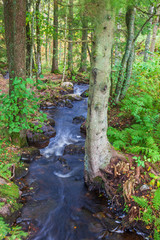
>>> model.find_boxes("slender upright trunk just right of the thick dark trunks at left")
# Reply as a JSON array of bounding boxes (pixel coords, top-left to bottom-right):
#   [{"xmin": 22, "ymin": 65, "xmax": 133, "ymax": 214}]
[{"xmin": 36, "ymin": 0, "xmax": 42, "ymax": 76}]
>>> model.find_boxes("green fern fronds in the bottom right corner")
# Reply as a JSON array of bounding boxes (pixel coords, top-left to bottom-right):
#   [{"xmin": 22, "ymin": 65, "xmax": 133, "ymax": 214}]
[{"xmin": 133, "ymin": 188, "xmax": 160, "ymax": 240}]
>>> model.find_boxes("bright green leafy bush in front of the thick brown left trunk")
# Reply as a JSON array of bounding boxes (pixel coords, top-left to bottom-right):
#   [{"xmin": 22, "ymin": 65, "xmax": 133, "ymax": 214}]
[{"xmin": 0, "ymin": 77, "xmax": 46, "ymax": 135}]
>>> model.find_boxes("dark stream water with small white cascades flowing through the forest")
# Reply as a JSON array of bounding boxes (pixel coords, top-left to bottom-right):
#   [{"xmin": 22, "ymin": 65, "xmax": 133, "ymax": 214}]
[{"xmin": 22, "ymin": 86, "xmax": 143, "ymax": 240}]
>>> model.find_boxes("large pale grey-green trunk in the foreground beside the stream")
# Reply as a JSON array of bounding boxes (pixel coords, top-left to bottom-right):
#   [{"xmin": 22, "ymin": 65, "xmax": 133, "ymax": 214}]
[{"xmin": 85, "ymin": 0, "xmax": 114, "ymax": 184}]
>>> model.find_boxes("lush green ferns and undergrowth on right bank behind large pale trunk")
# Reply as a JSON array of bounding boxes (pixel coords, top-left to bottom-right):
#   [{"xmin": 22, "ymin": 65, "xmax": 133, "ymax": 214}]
[{"xmin": 108, "ymin": 60, "xmax": 160, "ymax": 162}]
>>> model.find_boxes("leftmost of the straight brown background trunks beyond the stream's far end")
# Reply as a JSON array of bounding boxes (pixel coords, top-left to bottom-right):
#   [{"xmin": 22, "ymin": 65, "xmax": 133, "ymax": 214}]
[{"xmin": 51, "ymin": 0, "xmax": 58, "ymax": 73}]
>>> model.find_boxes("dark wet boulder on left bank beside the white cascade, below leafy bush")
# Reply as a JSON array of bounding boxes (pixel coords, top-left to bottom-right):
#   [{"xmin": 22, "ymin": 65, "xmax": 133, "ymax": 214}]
[{"xmin": 27, "ymin": 125, "xmax": 56, "ymax": 148}]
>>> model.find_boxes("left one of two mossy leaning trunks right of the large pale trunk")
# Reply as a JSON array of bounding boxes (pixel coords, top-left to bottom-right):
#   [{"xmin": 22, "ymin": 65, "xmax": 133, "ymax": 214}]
[{"xmin": 115, "ymin": 7, "xmax": 135, "ymax": 103}]
